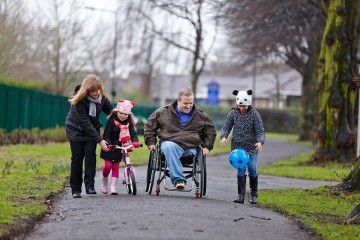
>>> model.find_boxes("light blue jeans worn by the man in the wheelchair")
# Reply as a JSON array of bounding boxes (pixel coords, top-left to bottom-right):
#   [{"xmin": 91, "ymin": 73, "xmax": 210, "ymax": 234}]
[{"xmin": 161, "ymin": 141, "xmax": 197, "ymax": 185}]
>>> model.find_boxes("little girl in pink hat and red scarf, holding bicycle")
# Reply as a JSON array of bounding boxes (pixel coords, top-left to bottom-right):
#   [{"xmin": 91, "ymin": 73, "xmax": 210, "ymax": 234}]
[{"xmin": 100, "ymin": 100, "xmax": 140, "ymax": 195}]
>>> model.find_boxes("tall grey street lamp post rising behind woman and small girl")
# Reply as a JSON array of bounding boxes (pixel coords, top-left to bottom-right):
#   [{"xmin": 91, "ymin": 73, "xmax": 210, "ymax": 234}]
[{"xmin": 85, "ymin": 6, "xmax": 120, "ymax": 101}]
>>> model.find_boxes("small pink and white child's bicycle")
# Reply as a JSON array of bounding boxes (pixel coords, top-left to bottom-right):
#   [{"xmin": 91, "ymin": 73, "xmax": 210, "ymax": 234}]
[{"xmin": 108, "ymin": 144, "xmax": 142, "ymax": 195}]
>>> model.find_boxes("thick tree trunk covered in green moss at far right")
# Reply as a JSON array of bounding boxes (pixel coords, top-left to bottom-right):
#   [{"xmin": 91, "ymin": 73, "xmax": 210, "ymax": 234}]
[{"xmin": 312, "ymin": 0, "xmax": 359, "ymax": 162}]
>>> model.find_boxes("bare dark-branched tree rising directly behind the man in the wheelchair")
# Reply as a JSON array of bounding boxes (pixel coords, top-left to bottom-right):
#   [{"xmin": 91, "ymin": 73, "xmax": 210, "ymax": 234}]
[{"xmin": 145, "ymin": 0, "xmax": 221, "ymax": 97}]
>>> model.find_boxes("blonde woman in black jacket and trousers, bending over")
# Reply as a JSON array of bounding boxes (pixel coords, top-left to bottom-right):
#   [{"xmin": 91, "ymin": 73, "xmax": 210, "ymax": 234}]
[{"xmin": 65, "ymin": 74, "xmax": 113, "ymax": 198}]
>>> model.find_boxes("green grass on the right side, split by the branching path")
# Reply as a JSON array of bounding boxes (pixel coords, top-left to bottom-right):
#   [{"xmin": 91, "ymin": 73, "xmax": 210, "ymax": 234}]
[{"xmin": 259, "ymin": 134, "xmax": 360, "ymax": 240}]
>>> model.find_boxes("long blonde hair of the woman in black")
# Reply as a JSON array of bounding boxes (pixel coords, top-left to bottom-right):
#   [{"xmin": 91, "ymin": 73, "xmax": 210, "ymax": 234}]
[{"xmin": 69, "ymin": 74, "xmax": 106, "ymax": 105}]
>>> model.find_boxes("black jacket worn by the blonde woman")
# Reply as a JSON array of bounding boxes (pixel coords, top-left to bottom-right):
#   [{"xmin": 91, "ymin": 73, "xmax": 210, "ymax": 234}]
[{"xmin": 65, "ymin": 97, "xmax": 113, "ymax": 143}]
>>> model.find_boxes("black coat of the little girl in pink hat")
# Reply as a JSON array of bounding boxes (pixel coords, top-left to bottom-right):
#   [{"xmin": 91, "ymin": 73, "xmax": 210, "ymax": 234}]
[{"xmin": 100, "ymin": 113, "xmax": 139, "ymax": 162}]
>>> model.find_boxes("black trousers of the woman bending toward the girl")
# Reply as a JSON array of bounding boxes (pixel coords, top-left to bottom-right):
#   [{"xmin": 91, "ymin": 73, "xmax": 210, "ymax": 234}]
[{"xmin": 70, "ymin": 141, "xmax": 97, "ymax": 193}]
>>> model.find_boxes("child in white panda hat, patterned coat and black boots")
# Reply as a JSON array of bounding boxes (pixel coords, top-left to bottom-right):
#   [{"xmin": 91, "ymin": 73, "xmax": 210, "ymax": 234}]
[{"xmin": 220, "ymin": 90, "xmax": 265, "ymax": 204}]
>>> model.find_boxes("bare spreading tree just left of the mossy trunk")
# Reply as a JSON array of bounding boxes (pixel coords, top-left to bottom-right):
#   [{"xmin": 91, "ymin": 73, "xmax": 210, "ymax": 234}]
[{"xmin": 222, "ymin": 0, "xmax": 325, "ymax": 139}]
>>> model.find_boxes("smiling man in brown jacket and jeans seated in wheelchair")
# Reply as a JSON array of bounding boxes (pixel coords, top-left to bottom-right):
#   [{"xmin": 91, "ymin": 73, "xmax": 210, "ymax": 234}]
[{"xmin": 144, "ymin": 88, "xmax": 216, "ymax": 189}]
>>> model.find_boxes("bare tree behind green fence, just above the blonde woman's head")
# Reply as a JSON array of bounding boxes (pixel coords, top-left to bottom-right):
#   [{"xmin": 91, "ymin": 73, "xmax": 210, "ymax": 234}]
[{"xmin": 32, "ymin": 0, "xmax": 95, "ymax": 94}]
